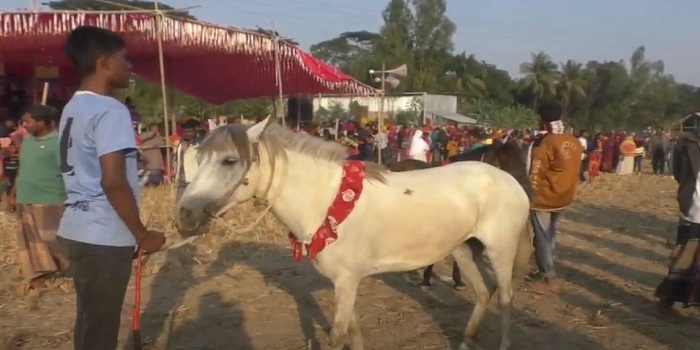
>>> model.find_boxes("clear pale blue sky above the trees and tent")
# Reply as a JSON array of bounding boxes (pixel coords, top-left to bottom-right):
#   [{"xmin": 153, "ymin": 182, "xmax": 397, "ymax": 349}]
[{"xmin": 5, "ymin": 0, "xmax": 700, "ymax": 86}]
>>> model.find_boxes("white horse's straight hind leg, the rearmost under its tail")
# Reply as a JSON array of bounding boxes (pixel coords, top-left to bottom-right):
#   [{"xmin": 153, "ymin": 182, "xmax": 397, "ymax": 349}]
[{"xmin": 486, "ymin": 249, "xmax": 515, "ymax": 350}]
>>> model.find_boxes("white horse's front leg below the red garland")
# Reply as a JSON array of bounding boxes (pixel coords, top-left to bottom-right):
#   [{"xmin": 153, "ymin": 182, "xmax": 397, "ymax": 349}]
[{"xmin": 330, "ymin": 275, "xmax": 364, "ymax": 350}]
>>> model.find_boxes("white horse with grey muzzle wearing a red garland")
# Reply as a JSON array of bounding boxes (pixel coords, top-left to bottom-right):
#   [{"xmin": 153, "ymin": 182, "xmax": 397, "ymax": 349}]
[{"xmin": 177, "ymin": 117, "xmax": 530, "ymax": 350}]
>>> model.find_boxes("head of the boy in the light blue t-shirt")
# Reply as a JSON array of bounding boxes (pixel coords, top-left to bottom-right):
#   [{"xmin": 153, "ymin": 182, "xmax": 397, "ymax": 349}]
[{"xmin": 64, "ymin": 26, "xmax": 131, "ymax": 89}]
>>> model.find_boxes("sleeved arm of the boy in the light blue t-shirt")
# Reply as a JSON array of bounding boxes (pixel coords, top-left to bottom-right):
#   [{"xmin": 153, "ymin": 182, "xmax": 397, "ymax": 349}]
[{"xmin": 94, "ymin": 108, "xmax": 148, "ymax": 242}]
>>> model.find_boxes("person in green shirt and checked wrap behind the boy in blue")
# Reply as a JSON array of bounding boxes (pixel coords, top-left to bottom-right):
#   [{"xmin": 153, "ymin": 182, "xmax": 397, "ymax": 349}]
[{"xmin": 9, "ymin": 105, "xmax": 68, "ymax": 289}]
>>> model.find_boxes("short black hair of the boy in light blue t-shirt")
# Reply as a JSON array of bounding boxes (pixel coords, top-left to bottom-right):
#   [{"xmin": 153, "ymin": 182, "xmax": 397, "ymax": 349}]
[{"xmin": 63, "ymin": 26, "xmax": 126, "ymax": 77}]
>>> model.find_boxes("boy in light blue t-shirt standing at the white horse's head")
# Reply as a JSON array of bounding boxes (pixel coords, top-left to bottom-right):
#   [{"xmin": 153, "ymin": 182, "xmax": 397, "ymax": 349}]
[{"xmin": 58, "ymin": 26, "xmax": 165, "ymax": 350}]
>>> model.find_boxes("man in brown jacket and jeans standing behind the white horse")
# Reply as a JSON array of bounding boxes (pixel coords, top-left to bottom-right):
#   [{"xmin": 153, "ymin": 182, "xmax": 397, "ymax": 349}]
[{"xmin": 528, "ymin": 103, "xmax": 583, "ymax": 293}]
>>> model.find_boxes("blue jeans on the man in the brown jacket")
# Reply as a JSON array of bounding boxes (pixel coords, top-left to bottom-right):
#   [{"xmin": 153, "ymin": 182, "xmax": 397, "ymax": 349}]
[{"xmin": 530, "ymin": 211, "xmax": 561, "ymax": 278}]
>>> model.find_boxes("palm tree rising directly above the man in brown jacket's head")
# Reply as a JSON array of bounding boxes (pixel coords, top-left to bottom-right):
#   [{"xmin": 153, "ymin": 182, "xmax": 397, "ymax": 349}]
[{"xmin": 520, "ymin": 51, "xmax": 558, "ymax": 108}]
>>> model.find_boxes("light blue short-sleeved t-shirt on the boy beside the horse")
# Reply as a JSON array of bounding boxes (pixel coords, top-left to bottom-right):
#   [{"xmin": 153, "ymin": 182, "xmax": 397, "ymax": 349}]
[{"xmin": 58, "ymin": 91, "xmax": 140, "ymax": 247}]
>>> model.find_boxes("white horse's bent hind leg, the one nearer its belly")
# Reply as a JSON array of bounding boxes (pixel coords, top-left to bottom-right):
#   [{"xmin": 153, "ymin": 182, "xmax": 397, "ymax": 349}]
[{"xmin": 452, "ymin": 244, "xmax": 494, "ymax": 350}]
